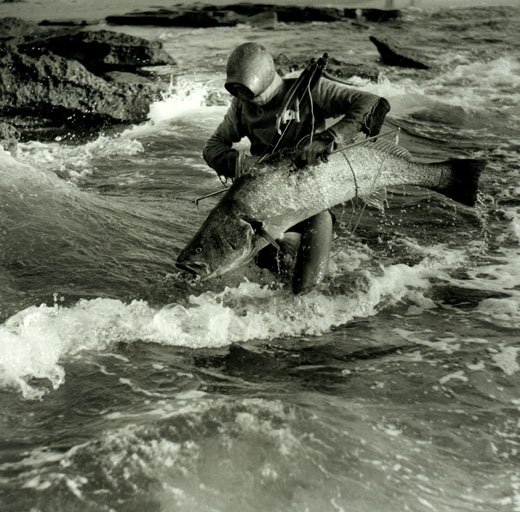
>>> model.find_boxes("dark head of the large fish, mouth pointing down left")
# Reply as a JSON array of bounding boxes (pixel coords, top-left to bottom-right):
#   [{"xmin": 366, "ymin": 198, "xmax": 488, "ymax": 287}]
[{"xmin": 176, "ymin": 208, "xmax": 266, "ymax": 280}]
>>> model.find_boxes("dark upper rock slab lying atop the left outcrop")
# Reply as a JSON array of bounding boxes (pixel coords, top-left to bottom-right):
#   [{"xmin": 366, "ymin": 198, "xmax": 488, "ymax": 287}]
[{"xmin": 19, "ymin": 30, "xmax": 175, "ymax": 75}]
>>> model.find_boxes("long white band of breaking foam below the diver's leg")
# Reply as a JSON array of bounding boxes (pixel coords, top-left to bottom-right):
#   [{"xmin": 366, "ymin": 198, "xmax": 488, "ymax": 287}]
[{"xmin": 0, "ymin": 247, "xmax": 464, "ymax": 398}]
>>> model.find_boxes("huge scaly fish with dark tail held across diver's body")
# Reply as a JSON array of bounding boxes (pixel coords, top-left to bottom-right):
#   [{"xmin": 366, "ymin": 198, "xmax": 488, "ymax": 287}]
[{"xmin": 177, "ymin": 141, "xmax": 485, "ymax": 279}]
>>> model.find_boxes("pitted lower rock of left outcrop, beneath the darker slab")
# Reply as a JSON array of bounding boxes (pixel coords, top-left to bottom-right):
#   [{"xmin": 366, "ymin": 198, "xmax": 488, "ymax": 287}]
[{"xmin": 0, "ymin": 44, "xmax": 162, "ymax": 138}]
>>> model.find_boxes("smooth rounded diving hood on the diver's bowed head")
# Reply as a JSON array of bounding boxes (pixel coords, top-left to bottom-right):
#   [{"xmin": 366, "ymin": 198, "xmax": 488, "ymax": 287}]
[{"xmin": 225, "ymin": 43, "xmax": 277, "ymax": 100}]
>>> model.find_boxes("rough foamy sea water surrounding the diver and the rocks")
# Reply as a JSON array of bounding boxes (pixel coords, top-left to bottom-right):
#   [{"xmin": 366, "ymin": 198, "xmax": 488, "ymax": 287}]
[{"xmin": 0, "ymin": 4, "xmax": 520, "ymax": 512}]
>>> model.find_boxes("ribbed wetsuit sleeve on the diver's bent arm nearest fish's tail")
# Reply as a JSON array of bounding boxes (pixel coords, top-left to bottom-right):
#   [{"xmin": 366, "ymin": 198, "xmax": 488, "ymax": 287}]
[{"xmin": 313, "ymin": 78, "xmax": 390, "ymax": 144}]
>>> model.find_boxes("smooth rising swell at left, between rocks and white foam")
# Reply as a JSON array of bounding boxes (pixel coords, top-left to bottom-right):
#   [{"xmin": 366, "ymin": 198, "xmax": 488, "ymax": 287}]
[{"xmin": 0, "ymin": 147, "xmax": 185, "ymax": 300}]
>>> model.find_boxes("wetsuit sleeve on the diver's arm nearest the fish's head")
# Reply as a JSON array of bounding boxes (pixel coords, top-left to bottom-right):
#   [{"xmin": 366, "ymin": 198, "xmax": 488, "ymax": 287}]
[{"xmin": 202, "ymin": 98, "xmax": 244, "ymax": 178}]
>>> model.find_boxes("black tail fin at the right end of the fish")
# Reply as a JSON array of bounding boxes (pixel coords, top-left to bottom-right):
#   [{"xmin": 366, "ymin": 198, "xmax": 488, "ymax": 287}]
[{"xmin": 435, "ymin": 158, "xmax": 487, "ymax": 206}]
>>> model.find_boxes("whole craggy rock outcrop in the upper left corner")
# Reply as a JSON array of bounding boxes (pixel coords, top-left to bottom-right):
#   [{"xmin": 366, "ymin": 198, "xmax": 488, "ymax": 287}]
[{"xmin": 0, "ymin": 18, "xmax": 174, "ymax": 147}]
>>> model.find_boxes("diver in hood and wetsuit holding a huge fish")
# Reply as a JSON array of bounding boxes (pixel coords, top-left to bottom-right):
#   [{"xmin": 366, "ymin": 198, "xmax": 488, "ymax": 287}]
[{"xmin": 203, "ymin": 43, "xmax": 390, "ymax": 293}]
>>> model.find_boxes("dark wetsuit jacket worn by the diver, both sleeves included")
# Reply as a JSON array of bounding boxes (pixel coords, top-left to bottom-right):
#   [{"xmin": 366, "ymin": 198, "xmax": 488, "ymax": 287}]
[{"xmin": 203, "ymin": 78, "xmax": 390, "ymax": 177}]
